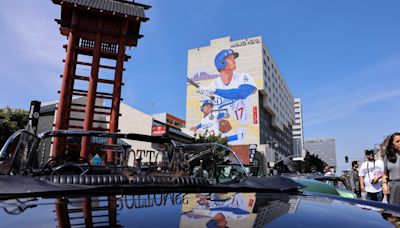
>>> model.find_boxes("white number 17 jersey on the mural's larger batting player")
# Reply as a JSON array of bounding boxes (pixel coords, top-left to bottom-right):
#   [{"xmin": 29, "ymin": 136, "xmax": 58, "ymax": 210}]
[{"xmin": 208, "ymin": 73, "xmax": 256, "ymax": 122}]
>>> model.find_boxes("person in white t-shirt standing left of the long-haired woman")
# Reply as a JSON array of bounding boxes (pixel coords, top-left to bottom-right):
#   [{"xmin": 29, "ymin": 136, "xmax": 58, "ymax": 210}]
[{"xmin": 359, "ymin": 150, "xmax": 384, "ymax": 201}]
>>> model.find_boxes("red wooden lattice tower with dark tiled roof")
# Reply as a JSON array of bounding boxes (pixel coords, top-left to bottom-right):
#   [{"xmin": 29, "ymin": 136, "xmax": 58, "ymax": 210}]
[{"xmin": 52, "ymin": 0, "xmax": 150, "ymax": 163}]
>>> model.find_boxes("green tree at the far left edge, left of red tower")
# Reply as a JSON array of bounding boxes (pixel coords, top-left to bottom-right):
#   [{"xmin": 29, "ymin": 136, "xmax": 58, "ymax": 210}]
[{"xmin": 0, "ymin": 107, "xmax": 28, "ymax": 148}]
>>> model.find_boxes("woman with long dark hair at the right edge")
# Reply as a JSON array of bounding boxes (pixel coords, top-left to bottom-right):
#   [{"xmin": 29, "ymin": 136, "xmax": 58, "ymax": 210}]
[{"xmin": 382, "ymin": 132, "xmax": 400, "ymax": 205}]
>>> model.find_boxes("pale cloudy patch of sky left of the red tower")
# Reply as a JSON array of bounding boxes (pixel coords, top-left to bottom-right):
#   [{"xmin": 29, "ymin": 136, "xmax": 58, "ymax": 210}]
[{"xmin": 0, "ymin": 0, "xmax": 65, "ymax": 107}]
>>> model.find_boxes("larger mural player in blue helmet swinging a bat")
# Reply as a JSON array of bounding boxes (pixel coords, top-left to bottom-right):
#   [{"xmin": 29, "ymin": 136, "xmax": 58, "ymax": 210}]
[{"xmin": 197, "ymin": 49, "xmax": 257, "ymax": 141}]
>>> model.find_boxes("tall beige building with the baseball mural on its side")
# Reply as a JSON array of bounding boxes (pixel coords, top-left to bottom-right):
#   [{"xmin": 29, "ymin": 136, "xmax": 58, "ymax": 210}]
[{"xmin": 186, "ymin": 36, "xmax": 294, "ymax": 164}]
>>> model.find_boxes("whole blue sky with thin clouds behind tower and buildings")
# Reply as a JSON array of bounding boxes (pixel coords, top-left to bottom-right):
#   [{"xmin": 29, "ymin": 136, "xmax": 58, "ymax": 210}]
[{"xmin": 0, "ymin": 0, "xmax": 400, "ymax": 173}]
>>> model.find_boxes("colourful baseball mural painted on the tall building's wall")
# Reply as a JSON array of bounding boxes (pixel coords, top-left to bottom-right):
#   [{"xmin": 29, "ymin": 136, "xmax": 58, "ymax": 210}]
[{"xmin": 187, "ymin": 37, "xmax": 260, "ymax": 145}]
